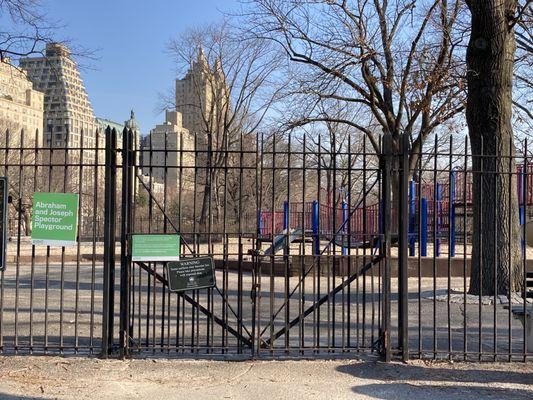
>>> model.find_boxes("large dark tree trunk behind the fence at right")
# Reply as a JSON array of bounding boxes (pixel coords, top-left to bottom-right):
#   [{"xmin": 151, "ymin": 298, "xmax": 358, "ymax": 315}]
[{"xmin": 466, "ymin": 0, "xmax": 523, "ymax": 295}]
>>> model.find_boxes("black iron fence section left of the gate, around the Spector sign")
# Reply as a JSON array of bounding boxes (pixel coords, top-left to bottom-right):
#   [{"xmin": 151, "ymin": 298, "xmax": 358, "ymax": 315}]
[{"xmin": 0, "ymin": 126, "xmax": 105, "ymax": 355}]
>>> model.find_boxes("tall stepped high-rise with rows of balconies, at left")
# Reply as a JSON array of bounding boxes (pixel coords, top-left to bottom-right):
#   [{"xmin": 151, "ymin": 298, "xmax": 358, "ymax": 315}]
[{"xmin": 20, "ymin": 43, "xmax": 101, "ymax": 192}]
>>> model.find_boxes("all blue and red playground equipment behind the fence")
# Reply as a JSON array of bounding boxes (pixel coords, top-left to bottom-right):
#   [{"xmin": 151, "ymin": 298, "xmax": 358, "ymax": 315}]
[{"xmin": 258, "ymin": 164, "xmax": 533, "ymax": 257}]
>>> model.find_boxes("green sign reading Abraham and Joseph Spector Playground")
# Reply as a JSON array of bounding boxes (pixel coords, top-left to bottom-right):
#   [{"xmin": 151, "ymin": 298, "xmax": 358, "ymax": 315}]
[{"xmin": 31, "ymin": 192, "xmax": 78, "ymax": 246}]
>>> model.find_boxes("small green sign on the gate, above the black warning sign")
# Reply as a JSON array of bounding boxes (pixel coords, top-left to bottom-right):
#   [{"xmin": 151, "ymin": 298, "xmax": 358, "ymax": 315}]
[{"xmin": 131, "ymin": 235, "xmax": 180, "ymax": 262}]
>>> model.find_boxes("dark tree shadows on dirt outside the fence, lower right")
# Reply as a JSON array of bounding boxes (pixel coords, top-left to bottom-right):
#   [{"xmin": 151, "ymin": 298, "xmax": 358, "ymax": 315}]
[{"xmin": 337, "ymin": 362, "xmax": 533, "ymax": 400}]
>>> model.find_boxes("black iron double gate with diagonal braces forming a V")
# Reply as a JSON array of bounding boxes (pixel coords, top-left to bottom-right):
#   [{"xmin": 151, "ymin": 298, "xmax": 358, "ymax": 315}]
[{"xmin": 104, "ymin": 126, "xmax": 390, "ymax": 357}]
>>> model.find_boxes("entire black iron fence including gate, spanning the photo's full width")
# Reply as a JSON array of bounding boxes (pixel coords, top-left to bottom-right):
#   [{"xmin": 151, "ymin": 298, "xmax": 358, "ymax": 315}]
[{"xmin": 0, "ymin": 129, "xmax": 533, "ymax": 360}]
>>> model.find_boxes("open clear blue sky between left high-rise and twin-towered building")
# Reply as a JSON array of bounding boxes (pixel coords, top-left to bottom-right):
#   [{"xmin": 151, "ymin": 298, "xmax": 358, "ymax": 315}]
[{"xmin": 44, "ymin": 0, "xmax": 237, "ymax": 134}]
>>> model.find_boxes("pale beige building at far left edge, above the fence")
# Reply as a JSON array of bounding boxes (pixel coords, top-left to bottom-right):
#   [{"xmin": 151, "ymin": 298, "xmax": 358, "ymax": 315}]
[{"xmin": 0, "ymin": 60, "xmax": 44, "ymax": 147}]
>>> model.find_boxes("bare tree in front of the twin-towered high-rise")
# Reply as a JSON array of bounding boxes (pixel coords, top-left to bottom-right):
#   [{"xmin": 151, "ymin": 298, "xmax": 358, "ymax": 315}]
[{"xmin": 169, "ymin": 22, "xmax": 280, "ymax": 228}]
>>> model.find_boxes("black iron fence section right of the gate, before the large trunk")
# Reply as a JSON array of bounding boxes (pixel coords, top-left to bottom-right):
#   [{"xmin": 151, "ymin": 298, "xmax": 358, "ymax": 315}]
[{"xmin": 391, "ymin": 137, "xmax": 533, "ymax": 361}]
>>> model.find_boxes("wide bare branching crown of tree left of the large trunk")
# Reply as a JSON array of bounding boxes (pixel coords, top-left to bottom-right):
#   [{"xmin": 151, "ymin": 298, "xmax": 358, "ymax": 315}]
[{"xmin": 245, "ymin": 0, "xmax": 465, "ymax": 194}]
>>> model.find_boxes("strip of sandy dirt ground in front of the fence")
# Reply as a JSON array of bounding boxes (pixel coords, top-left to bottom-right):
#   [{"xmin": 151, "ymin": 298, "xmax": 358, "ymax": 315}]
[{"xmin": 0, "ymin": 357, "xmax": 533, "ymax": 400}]
